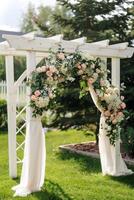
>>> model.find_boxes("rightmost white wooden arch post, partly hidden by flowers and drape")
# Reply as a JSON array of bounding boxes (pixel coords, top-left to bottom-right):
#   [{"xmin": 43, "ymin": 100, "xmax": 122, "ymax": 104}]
[{"xmin": 112, "ymin": 58, "xmax": 120, "ymax": 172}]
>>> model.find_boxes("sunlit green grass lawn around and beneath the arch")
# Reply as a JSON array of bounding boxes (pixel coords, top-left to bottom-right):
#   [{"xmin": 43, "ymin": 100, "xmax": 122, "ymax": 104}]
[{"xmin": 0, "ymin": 130, "xmax": 134, "ymax": 200}]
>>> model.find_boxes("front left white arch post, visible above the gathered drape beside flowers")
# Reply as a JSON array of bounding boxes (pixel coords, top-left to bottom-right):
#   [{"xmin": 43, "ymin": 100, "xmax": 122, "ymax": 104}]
[{"xmin": 26, "ymin": 51, "xmax": 36, "ymax": 123}]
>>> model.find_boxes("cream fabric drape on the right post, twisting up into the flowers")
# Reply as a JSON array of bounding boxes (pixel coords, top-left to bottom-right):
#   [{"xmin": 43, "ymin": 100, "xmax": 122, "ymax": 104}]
[{"xmin": 89, "ymin": 85, "xmax": 133, "ymax": 176}]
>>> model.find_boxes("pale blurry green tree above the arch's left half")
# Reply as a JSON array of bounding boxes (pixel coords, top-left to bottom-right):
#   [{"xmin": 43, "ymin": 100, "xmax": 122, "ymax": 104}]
[{"xmin": 21, "ymin": 3, "xmax": 69, "ymax": 37}]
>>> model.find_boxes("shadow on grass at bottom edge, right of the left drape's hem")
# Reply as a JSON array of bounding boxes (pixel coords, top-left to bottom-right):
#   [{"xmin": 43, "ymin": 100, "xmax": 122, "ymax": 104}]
[{"xmin": 33, "ymin": 180, "xmax": 71, "ymax": 200}]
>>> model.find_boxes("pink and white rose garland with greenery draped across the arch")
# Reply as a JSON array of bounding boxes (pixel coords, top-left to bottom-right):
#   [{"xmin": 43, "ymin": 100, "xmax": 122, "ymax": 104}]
[{"xmin": 28, "ymin": 47, "xmax": 126, "ymax": 145}]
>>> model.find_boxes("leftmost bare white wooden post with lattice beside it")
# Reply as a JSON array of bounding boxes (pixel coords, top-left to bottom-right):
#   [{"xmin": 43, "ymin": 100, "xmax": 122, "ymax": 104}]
[{"xmin": 6, "ymin": 55, "xmax": 17, "ymax": 178}]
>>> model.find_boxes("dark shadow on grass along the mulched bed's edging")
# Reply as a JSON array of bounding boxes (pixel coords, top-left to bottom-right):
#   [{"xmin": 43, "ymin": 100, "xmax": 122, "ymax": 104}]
[{"xmin": 57, "ymin": 151, "xmax": 101, "ymax": 173}]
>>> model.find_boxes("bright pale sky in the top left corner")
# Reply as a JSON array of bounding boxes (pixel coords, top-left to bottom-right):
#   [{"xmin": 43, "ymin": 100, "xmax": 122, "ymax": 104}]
[{"xmin": 0, "ymin": 0, "xmax": 56, "ymax": 31}]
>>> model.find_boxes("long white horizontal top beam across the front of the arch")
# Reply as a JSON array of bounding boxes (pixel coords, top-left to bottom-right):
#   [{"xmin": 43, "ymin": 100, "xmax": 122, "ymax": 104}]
[{"xmin": 3, "ymin": 35, "xmax": 134, "ymax": 58}]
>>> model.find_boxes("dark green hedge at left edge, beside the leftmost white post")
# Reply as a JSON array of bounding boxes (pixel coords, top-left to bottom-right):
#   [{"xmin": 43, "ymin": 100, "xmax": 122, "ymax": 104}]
[{"xmin": 0, "ymin": 99, "xmax": 7, "ymax": 131}]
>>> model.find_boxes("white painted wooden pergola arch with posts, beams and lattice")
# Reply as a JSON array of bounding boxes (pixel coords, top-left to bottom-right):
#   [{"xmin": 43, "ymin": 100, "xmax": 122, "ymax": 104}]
[{"xmin": 0, "ymin": 33, "xmax": 134, "ymax": 178}]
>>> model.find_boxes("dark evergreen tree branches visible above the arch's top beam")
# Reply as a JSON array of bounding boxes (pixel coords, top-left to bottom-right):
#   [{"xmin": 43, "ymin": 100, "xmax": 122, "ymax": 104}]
[{"xmin": 54, "ymin": 0, "xmax": 133, "ymax": 42}]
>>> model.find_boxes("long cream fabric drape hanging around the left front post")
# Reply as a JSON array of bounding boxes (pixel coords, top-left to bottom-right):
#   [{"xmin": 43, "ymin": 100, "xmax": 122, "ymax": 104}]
[{"xmin": 12, "ymin": 118, "xmax": 46, "ymax": 196}]
